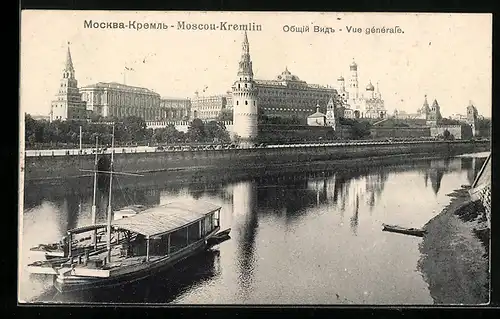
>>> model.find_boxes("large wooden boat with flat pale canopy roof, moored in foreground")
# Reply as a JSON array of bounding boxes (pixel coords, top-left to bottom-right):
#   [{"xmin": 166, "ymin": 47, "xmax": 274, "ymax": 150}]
[{"xmin": 54, "ymin": 201, "xmax": 225, "ymax": 292}]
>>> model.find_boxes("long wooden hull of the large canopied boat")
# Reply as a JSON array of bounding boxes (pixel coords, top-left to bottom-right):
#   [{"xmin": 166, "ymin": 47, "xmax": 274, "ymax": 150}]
[{"xmin": 54, "ymin": 229, "xmax": 219, "ymax": 293}]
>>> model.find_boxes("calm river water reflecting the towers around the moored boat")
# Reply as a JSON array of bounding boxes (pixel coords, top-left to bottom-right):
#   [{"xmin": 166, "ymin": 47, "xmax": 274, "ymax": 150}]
[{"xmin": 19, "ymin": 153, "xmax": 486, "ymax": 304}]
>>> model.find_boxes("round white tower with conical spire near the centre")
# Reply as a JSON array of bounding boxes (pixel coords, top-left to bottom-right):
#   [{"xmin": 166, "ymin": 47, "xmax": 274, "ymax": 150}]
[{"xmin": 232, "ymin": 31, "xmax": 258, "ymax": 143}]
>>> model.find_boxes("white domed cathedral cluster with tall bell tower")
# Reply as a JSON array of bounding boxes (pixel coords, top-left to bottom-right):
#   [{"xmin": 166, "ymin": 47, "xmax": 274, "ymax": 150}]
[{"xmin": 337, "ymin": 60, "xmax": 387, "ymax": 119}]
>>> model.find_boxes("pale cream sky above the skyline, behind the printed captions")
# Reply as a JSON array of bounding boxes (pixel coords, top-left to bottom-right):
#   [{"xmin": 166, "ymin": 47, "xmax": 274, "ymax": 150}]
[{"xmin": 20, "ymin": 10, "xmax": 492, "ymax": 117}]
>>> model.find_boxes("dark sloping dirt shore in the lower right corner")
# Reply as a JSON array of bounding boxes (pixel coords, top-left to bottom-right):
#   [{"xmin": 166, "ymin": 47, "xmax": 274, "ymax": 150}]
[{"xmin": 418, "ymin": 188, "xmax": 489, "ymax": 305}]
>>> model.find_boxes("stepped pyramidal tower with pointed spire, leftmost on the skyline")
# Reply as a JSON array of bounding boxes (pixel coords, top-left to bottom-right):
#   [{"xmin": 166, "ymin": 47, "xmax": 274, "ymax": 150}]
[{"xmin": 50, "ymin": 42, "xmax": 87, "ymax": 122}]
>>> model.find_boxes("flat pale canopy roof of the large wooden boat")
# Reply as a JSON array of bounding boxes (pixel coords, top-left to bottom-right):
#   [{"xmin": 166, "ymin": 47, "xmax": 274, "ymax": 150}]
[{"xmin": 112, "ymin": 201, "xmax": 221, "ymax": 237}]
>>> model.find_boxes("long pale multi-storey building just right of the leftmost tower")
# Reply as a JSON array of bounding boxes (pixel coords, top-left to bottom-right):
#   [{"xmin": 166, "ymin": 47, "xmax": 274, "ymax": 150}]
[{"xmin": 80, "ymin": 82, "xmax": 160, "ymax": 121}]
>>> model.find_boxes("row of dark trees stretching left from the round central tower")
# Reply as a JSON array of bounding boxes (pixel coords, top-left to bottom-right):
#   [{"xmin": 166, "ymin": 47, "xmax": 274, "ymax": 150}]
[{"xmin": 25, "ymin": 114, "xmax": 230, "ymax": 149}]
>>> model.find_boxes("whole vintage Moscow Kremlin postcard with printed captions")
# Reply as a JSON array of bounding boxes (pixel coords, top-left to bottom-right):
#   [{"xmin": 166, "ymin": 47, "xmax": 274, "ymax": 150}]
[{"xmin": 17, "ymin": 10, "xmax": 492, "ymax": 306}]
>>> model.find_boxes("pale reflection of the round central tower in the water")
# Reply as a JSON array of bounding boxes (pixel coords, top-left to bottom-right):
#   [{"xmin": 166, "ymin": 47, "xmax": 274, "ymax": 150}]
[{"xmin": 233, "ymin": 181, "xmax": 259, "ymax": 299}]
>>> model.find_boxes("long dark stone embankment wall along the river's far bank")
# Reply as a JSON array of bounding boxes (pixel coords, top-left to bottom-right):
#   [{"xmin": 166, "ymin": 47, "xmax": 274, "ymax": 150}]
[{"xmin": 24, "ymin": 141, "xmax": 490, "ymax": 181}]
